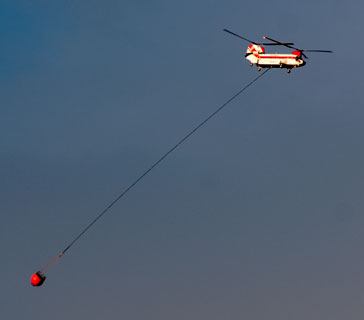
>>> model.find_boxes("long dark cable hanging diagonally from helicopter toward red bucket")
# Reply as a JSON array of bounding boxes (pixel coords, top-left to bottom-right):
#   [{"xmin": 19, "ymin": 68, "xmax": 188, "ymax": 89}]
[{"xmin": 41, "ymin": 69, "xmax": 269, "ymax": 271}]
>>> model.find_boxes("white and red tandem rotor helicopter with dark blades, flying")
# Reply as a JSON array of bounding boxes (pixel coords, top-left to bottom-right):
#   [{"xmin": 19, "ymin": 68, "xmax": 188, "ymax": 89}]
[{"xmin": 224, "ymin": 29, "xmax": 332, "ymax": 73}]
